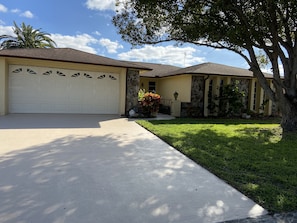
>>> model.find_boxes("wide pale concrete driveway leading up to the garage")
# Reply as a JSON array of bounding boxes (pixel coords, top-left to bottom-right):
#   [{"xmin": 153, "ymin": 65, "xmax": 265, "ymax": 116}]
[{"xmin": 0, "ymin": 114, "xmax": 266, "ymax": 223}]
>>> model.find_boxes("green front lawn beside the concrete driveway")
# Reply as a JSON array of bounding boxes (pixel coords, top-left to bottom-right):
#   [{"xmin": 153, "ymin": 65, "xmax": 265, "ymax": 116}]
[{"xmin": 138, "ymin": 119, "xmax": 297, "ymax": 212}]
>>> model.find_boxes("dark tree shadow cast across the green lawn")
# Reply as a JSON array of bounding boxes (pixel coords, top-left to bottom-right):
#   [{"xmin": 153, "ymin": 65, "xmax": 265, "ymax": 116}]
[{"xmin": 152, "ymin": 126, "xmax": 297, "ymax": 212}]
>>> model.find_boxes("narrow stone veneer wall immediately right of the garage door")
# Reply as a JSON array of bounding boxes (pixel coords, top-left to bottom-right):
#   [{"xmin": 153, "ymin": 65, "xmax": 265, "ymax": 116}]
[{"xmin": 126, "ymin": 69, "xmax": 140, "ymax": 115}]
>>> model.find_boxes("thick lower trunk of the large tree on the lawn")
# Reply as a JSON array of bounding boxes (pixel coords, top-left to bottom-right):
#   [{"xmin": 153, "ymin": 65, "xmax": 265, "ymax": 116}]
[{"xmin": 280, "ymin": 95, "xmax": 297, "ymax": 136}]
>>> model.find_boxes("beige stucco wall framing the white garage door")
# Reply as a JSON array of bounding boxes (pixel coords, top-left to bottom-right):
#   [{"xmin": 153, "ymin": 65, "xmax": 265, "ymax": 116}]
[{"xmin": 0, "ymin": 57, "xmax": 127, "ymax": 115}]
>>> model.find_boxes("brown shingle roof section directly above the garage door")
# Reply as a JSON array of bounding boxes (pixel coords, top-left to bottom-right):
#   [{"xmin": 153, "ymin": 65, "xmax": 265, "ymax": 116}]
[{"xmin": 0, "ymin": 48, "xmax": 150, "ymax": 70}]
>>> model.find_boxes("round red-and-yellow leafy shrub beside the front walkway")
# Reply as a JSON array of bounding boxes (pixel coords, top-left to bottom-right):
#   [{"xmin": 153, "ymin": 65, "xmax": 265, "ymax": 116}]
[{"xmin": 139, "ymin": 92, "xmax": 161, "ymax": 115}]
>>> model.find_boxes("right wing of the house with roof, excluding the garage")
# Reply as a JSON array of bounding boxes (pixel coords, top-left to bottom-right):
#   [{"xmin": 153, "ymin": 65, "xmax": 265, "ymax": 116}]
[{"xmin": 134, "ymin": 63, "xmax": 278, "ymax": 117}]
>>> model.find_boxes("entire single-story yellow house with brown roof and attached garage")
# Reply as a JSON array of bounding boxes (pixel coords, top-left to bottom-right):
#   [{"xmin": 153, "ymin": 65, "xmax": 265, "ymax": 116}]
[{"xmin": 0, "ymin": 48, "xmax": 278, "ymax": 116}]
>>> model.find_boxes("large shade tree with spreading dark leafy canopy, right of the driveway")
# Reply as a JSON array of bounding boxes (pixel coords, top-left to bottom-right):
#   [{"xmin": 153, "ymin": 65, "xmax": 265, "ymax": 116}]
[{"xmin": 113, "ymin": 0, "xmax": 297, "ymax": 136}]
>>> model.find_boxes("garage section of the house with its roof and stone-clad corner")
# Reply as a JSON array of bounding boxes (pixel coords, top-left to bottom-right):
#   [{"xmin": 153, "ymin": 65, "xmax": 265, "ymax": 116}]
[{"xmin": 0, "ymin": 48, "xmax": 147, "ymax": 115}]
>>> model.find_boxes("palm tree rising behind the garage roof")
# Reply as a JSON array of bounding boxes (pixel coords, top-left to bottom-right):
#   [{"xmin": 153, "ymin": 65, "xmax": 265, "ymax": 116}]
[{"xmin": 0, "ymin": 22, "xmax": 56, "ymax": 50}]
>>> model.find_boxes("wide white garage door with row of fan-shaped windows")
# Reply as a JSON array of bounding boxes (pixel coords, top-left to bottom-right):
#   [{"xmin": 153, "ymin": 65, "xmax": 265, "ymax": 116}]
[{"xmin": 9, "ymin": 65, "xmax": 119, "ymax": 114}]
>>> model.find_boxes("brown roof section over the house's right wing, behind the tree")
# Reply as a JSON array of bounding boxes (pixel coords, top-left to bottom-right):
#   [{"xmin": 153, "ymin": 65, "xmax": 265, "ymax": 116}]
[{"xmin": 140, "ymin": 63, "xmax": 272, "ymax": 78}]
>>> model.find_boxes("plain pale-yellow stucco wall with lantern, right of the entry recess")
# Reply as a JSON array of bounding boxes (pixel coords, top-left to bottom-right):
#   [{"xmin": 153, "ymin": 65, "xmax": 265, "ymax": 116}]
[{"xmin": 158, "ymin": 75, "xmax": 192, "ymax": 102}]
